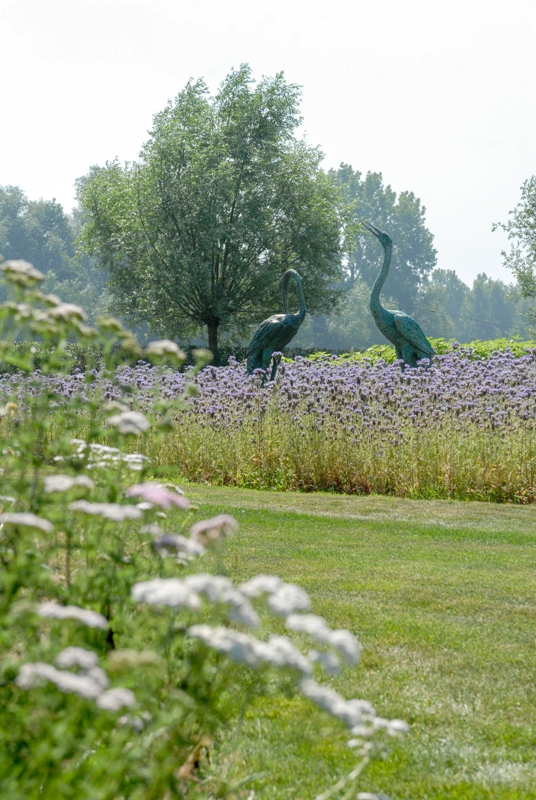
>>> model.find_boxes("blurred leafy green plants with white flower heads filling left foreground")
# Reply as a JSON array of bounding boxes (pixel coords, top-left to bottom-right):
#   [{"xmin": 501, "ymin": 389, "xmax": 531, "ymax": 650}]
[{"xmin": 0, "ymin": 262, "xmax": 408, "ymax": 800}]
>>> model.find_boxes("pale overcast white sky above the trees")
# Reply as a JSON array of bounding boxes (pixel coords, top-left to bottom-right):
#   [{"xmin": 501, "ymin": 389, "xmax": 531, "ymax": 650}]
[{"xmin": 0, "ymin": 0, "xmax": 536, "ymax": 282}]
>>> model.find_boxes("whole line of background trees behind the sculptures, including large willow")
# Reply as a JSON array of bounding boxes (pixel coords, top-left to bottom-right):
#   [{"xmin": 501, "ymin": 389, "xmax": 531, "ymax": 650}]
[{"xmin": 0, "ymin": 65, "xmax": 536, "ymax": 358}]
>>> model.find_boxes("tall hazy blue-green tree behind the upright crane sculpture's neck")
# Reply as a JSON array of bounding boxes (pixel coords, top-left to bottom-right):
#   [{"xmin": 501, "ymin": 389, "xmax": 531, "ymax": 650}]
[{"xmin": 330, "ymin": 164, "xmax": 437, "ymax": 310}]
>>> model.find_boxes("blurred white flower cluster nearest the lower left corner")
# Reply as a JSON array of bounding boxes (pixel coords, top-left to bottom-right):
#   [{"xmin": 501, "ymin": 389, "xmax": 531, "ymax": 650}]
[{"xmin": 15, "ymin": 647, "xmax": 136, "ymax": 711}]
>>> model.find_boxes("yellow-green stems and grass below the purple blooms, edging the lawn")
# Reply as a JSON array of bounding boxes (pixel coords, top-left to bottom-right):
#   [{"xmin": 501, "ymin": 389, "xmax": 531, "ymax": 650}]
[{"xmin": 156, "ymin": 412, "xmax": 536, "ymax": 503}]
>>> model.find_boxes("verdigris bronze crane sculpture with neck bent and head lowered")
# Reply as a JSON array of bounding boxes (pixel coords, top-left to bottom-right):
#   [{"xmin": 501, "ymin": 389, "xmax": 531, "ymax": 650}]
[{"xmin": 246, "ymin": 269, "xmax": 307, "ymax": 381}]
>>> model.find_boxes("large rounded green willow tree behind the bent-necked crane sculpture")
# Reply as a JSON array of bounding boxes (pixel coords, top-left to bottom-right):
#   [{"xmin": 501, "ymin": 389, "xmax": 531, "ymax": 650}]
[{"xmin": 78, "ymin": 65, "xmax": 341, "ymax": 352}]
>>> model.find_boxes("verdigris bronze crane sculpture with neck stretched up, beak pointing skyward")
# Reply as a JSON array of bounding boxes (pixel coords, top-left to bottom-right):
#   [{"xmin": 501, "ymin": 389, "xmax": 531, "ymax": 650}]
[{"xmin": 362, "ymin": 222, "xmax": 435, "ymax": 367}]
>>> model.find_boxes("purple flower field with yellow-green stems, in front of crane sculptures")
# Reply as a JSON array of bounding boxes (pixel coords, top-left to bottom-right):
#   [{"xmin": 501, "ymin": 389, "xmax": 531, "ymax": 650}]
[{"xmin": 0, "ymin": 348, "xmax": 536, "ymax": 502}]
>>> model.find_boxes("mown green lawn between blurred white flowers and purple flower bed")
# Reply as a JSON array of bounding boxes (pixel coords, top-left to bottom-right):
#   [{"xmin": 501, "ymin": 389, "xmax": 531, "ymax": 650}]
[{"xmin": 181, "ymin": 485, "xmax": 536, "ymax": 800}]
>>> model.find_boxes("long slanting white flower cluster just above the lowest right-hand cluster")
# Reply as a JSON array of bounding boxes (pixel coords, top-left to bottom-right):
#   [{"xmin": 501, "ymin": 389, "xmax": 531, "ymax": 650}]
[{"xmin": 188, "ymin": 625, "xmax": 312, "ymax": 675}]
